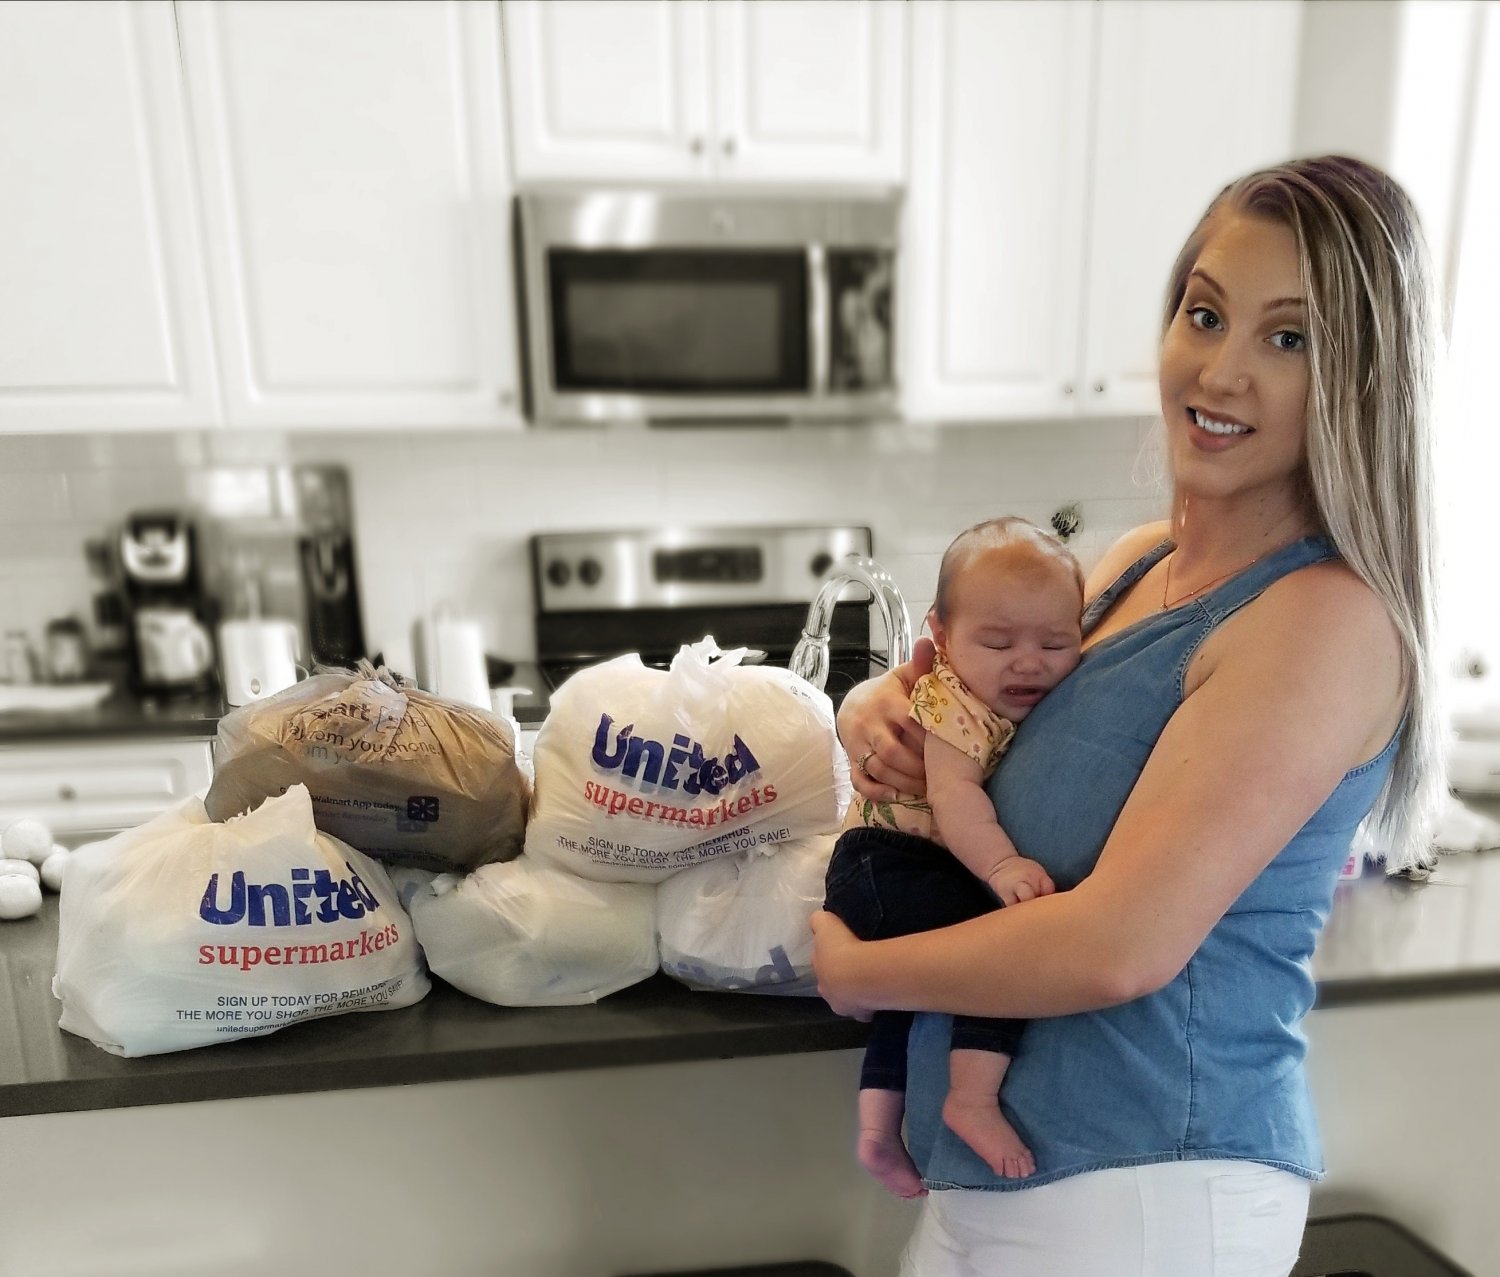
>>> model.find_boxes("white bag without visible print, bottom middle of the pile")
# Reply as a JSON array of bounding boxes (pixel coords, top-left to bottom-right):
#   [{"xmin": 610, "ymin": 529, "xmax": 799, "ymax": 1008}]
[{"xmin": 410, "ymin": 855, "xmax": 657, "ymax": 1007}]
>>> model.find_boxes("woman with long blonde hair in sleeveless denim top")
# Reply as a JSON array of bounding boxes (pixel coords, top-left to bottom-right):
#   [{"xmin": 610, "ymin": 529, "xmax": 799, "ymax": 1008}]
[{"xmin": 815, "ymin": 158, "xmax": 1439, "ymax": 1277}]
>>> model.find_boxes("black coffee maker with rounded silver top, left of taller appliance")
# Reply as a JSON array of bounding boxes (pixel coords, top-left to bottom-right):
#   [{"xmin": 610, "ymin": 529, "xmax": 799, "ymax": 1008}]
[{"xmin": 120, "ymin": 510, "xmax": 216, "ymax": 696}]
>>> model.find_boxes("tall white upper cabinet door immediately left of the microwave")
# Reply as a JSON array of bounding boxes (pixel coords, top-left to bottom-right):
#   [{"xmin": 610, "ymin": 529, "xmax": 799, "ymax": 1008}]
[{"xmin": 177, "ymin": 0, "xmax": 521, "ymax": 428}]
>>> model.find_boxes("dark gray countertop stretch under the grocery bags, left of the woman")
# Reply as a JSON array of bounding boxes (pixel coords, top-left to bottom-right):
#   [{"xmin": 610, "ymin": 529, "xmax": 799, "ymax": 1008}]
[{"xmin": 0, "ymin": 894, "xmax": 866, "ymax": 1116}]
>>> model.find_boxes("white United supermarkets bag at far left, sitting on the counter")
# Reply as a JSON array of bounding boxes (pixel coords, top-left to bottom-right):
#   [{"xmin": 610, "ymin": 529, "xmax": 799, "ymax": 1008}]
[{"xmin": 53, "ymin": 785, "xmax": 431, "ymax": 1055}]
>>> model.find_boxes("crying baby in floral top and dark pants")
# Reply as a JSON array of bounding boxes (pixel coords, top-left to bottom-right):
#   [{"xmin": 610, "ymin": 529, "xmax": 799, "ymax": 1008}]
[{"xmin": 825, "ymin": 518, "xmax": 1083, "ymax": 1197}]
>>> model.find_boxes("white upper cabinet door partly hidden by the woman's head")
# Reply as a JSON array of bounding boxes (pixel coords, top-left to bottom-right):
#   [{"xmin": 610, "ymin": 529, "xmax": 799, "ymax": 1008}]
[{"xmin": 1083, "ymin": 0, "xmax": 1301, "ymax": 416}]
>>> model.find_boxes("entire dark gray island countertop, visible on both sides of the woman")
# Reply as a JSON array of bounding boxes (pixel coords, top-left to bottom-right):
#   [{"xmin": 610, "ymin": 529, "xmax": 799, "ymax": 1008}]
[{"xmin": 0, "ymin": 852, "xmax": 1500, "ymax": 1116}]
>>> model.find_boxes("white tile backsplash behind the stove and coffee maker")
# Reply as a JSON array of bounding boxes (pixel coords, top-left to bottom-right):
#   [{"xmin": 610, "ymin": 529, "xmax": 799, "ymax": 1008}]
[{"xmin": 0, "ymin": 420, "xmax": 1166, "ymax": 668}]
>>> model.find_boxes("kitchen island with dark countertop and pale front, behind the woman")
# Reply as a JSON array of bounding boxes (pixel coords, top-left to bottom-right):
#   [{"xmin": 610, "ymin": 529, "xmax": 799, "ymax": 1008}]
[{"xmin": 0, "ymin": 854, "xmax": 1500, "ymax": 1277}]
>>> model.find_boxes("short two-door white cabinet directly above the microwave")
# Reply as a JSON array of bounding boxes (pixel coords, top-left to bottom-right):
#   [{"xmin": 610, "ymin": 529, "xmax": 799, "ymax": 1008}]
[{"xmin": 504, "ymin": 0, "xmax": 909, "ymax": 183}]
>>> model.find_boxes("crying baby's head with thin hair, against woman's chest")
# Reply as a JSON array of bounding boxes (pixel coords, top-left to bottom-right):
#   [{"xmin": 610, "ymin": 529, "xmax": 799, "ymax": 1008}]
[{"xmin": 927, "ymin": 518, "xmax": 1083, "ymax": 722}]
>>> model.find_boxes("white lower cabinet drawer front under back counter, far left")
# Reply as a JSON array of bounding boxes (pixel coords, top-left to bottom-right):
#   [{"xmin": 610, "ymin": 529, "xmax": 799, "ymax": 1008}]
[{"xmin": 0, "ymin": 738, "xmax": 213, "ymax": 836}]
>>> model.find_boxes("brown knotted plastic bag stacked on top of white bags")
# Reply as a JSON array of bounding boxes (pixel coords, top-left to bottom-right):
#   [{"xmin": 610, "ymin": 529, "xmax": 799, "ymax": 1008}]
[{"xmin": 204, "ymin": 662, "xmax": 531, "ymax": 873}]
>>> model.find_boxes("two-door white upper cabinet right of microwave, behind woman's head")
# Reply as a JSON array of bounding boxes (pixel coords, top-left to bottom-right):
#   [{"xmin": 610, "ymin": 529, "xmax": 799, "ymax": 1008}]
[{"xmin": 903, "ymin": 0, "xmax": 1301, "ymax": 420}]
